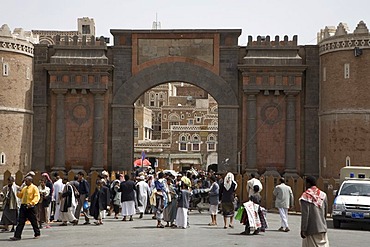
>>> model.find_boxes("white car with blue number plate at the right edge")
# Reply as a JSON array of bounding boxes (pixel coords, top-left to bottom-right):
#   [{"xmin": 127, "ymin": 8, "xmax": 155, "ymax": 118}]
[{"xmin": 332, "ymin": 179, "xmax": 370, "ymax": 228}]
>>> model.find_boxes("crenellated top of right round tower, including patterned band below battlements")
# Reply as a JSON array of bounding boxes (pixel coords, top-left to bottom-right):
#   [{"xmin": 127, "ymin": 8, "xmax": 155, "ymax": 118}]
[{"xmin": 317, "ymin": 21, "xmax": 370, "ymax": 55}]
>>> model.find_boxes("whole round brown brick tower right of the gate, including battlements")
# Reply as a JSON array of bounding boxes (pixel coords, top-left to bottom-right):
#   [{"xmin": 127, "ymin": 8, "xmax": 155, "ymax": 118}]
[{"xmin": 318, "ymin": 21, "xmax": 370, "ymax": 177}]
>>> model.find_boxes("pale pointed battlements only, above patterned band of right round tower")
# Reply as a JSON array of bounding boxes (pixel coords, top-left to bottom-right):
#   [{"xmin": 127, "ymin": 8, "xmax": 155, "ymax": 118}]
[{"xmin": 317, "ymin": 21, "xmax": 369, "ymax": 43}]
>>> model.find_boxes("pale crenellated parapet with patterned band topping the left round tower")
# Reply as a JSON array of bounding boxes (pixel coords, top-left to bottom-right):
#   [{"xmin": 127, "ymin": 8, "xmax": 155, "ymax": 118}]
[{"xmin": 0, "ymin": 24, "xmax": 39, "ymax": 57}]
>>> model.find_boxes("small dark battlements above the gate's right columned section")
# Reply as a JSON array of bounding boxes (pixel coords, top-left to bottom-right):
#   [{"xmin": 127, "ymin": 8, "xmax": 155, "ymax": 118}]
[{"xmin": 247, "ymin": 35, "xmax": 298, "ymax": 48}]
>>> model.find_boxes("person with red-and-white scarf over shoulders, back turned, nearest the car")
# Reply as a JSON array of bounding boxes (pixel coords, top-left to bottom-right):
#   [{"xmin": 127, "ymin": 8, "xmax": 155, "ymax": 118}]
[{"xmin": 299, "ymin": 176, "xmax": 329, "ymax": 247}]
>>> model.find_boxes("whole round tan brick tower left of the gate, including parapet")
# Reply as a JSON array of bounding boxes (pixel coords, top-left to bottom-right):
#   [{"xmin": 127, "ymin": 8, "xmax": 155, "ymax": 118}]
[{"xmin": 0, "ymin": 24, "xmax": 37, "ymax": 174}]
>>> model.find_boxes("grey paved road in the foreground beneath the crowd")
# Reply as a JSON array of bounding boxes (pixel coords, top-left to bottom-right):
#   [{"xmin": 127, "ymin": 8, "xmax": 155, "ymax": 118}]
[{"xmin": 0, "ymin": 211, "xmax": 370, "ymax": 247}]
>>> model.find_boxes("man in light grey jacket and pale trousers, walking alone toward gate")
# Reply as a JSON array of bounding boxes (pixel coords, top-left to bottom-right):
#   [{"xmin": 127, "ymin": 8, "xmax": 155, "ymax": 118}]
[{"xmin": 273, "ymin": 178, "xmax": 294, "ymax": 232}]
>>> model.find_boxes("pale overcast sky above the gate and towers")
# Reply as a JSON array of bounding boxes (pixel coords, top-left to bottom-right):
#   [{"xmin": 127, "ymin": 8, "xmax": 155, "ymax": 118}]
[{"xmin": 0, "ymin": 0, "xmax": 370, "ymax": 46}]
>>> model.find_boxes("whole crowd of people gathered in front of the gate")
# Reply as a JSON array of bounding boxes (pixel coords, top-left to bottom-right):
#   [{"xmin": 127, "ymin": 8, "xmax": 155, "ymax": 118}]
[{"xmin": 0, "ymin": 169, "xmax": 329, "ymax": 246}]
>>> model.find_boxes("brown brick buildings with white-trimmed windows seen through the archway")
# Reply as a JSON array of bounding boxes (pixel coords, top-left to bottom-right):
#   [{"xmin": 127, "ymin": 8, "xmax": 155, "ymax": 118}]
[{"xmin": 134, "ymin": 82, "xmax": 218, "ymax": 170}]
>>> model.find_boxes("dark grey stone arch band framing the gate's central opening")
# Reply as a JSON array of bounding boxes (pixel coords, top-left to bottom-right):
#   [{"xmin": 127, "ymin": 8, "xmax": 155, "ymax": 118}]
[{"xmin": 112, "ymin": 62, "xmax": 239, "ymax": 171}]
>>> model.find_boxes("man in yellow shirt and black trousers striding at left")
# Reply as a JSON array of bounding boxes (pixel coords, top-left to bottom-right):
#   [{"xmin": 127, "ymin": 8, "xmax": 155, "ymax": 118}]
[{"xmin": 10, "ymin": 176, "xmax": 41, "ymax": 240}]
